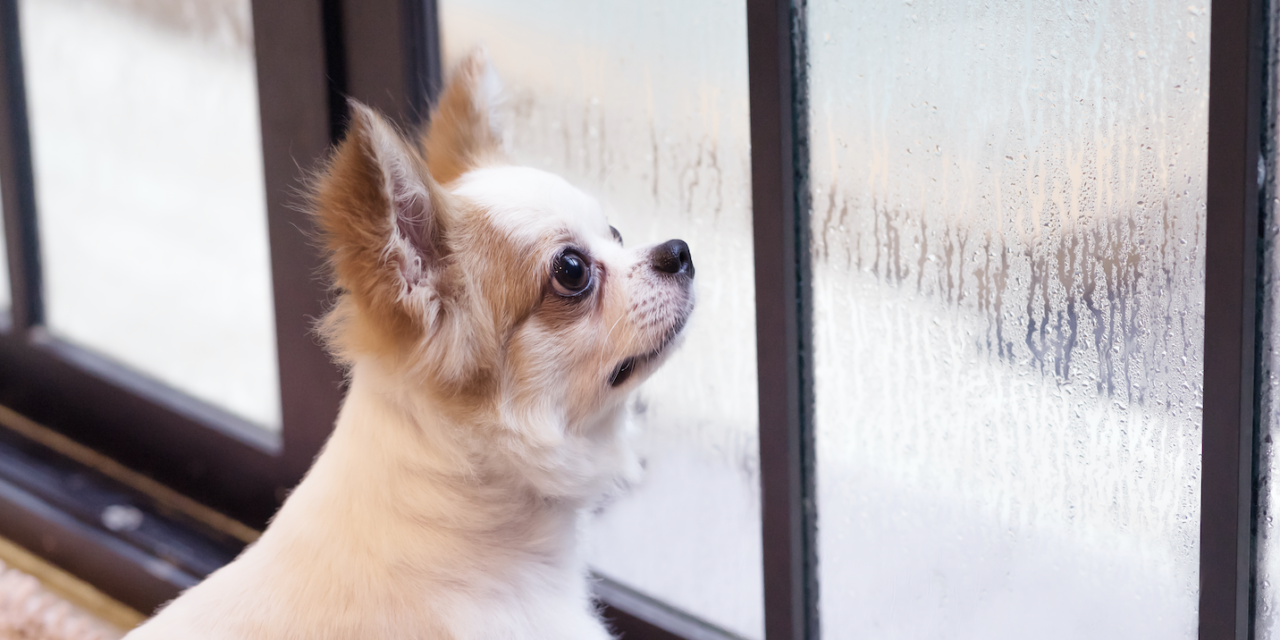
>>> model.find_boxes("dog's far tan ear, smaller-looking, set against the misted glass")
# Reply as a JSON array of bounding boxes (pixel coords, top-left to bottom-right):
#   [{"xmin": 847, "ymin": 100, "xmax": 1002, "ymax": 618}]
[{"xmin": 422, "ymin": 49, "xmax": 503, "ymax": 184}]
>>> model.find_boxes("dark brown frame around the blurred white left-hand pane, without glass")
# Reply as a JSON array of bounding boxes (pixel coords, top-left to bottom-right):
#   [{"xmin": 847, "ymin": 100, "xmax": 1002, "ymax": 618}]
[{"xmin": 0, "ymin": 0, "xmax": 357, "ymax": 527}]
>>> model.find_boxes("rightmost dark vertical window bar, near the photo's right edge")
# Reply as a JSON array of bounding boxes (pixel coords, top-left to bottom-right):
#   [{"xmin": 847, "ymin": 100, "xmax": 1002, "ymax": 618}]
[{"xmin": 1199, "ymin": 0, "xmax": 1274, "ymax": 640}]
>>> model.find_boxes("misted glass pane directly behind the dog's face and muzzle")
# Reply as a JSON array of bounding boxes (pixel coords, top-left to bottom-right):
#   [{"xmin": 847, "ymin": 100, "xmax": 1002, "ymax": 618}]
[{"xmin": 439, "ymin": 0, "xmax": 763, "ymax": 637}]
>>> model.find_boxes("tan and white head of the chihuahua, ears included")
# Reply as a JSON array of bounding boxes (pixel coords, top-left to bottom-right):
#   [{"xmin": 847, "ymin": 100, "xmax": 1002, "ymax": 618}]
[{"xmin": 316, "ymin": 54, "xmax": 694, "ymax": 478}]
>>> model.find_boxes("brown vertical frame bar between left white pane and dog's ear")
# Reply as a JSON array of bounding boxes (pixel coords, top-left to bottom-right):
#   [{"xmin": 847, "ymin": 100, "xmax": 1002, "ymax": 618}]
[{"xmin": 245, "ymin": 0, "xmax": 342, "ymax": 483}]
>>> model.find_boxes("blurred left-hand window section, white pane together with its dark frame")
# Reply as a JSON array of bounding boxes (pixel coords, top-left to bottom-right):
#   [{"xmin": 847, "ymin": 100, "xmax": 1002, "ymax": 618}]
[{"xmin": 0, "ymin": 0, "xmax": 340, "ymax": 535}]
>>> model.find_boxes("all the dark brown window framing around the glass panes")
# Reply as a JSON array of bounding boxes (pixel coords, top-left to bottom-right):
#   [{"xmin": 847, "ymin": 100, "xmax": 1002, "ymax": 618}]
[{"xmin": 0, "ymin": 0, "xmax": 1280, "ymax": 640}]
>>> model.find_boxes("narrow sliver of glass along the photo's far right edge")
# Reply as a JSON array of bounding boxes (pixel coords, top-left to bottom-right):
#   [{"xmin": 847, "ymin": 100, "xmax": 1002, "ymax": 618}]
[{"xmin": 1253, "ymin": 0, "xmax": 1280, "ymax": 640}]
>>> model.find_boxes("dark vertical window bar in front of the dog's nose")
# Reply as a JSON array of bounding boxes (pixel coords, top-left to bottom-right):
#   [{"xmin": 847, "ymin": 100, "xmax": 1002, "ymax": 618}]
[{"xmin": 746, "ymin": 0, "xmax": 818, "ymax": 640}]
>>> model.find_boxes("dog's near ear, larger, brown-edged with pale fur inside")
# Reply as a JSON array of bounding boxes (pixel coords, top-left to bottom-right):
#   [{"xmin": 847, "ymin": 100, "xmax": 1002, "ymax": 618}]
[{"xmin": 316, "ymin": 101, "xmax": 448, "ymax": 350}]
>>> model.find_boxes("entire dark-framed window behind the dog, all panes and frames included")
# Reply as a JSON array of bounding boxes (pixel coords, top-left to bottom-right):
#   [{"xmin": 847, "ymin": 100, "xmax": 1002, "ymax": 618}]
[{"xmin": 0, "ymin": 0, "xmax": 1280, "ymax": 640}]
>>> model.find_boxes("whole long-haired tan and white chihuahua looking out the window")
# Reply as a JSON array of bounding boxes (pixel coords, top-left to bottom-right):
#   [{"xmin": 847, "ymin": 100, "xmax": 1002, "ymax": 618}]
[{"xmin": 127, "ymin": 52, "xmax": 694, "ymax": 640}]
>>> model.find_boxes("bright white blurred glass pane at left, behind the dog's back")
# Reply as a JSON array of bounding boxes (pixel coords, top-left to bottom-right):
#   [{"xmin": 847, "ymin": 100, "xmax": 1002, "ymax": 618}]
[{"xmin": 19, "ymin": 0, "xmax": 280, "ymax": 430}]
